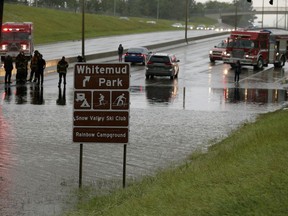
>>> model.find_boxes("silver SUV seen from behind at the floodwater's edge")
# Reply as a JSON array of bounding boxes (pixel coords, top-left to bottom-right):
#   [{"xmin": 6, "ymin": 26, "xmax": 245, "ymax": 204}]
[{"xmin": 145, "ymin": 53, "xmax": 180, "ymax": 79}]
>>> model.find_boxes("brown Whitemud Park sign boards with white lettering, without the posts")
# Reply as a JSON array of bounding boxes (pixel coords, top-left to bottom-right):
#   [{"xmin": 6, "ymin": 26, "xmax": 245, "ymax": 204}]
[{"xmin": 73, "ymin": 63, "xmax": 130, "ymax": 143}]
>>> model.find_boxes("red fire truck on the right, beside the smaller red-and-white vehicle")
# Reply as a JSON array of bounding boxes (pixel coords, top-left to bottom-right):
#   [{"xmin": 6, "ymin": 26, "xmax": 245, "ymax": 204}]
[{"xmin": 223, "ymin": 30, "xmax": 288, "ymax": 69}]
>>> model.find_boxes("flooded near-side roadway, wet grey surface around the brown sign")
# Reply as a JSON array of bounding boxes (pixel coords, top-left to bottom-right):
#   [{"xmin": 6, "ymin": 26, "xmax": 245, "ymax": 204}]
[{"xmin": 0, "ymin": 34, "xmax": 288, "ymax": 216}]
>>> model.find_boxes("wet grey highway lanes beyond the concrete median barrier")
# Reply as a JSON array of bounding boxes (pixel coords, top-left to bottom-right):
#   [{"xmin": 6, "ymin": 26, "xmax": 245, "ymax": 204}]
[{"xmin": 35, "ymin": 30, "xmax": 227, "ymax": 60}]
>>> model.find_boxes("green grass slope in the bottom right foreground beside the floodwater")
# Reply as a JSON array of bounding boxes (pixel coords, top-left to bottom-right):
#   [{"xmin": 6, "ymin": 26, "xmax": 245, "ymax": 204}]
[{"xmin": 66, "ymin": 110, "xmax": 288, "ymax": 216}]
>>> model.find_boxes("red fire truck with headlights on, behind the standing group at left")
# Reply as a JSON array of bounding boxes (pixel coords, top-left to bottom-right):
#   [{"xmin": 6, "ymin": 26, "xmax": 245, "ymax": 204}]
[{"xmin": 0, "ymin": 22, "xmax": 34, "ymax": 61}]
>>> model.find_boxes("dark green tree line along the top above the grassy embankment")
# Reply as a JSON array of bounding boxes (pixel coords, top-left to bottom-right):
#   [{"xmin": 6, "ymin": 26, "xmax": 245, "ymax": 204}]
[{"xmin": 5, "ymin": 0, "xmax": 255, "ymax": 26}]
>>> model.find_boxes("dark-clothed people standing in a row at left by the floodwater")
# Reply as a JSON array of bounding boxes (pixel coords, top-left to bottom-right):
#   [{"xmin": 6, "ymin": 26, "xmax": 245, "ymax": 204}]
[{"xmin": 4, "ymin": 50, "xmax": 70, "ymax": 87}]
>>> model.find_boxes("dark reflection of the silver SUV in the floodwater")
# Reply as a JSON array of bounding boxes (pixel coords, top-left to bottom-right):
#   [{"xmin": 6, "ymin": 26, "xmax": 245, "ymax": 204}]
[{"xmin": 145, "ymin": 78, "xmax": 178, "ymax": 104}]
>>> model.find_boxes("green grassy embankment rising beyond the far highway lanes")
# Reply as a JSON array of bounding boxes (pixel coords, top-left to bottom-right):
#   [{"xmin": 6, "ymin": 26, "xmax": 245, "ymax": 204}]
[{"xmin": 3, "ymin": 4, "xmax": 216, "ymax": 44}]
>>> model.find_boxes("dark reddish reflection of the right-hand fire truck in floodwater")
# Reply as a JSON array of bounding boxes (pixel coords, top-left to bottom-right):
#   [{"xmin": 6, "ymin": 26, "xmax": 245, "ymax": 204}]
[{"xmin": 224, "ymin": 87, "xmax": 288, "ymax": 104}]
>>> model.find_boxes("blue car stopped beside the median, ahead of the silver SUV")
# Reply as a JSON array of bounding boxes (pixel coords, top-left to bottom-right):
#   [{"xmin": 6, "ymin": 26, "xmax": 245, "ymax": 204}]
[{"xmin": 124, "ymin": 47, "xmax": 151, "ymax": 65}]
